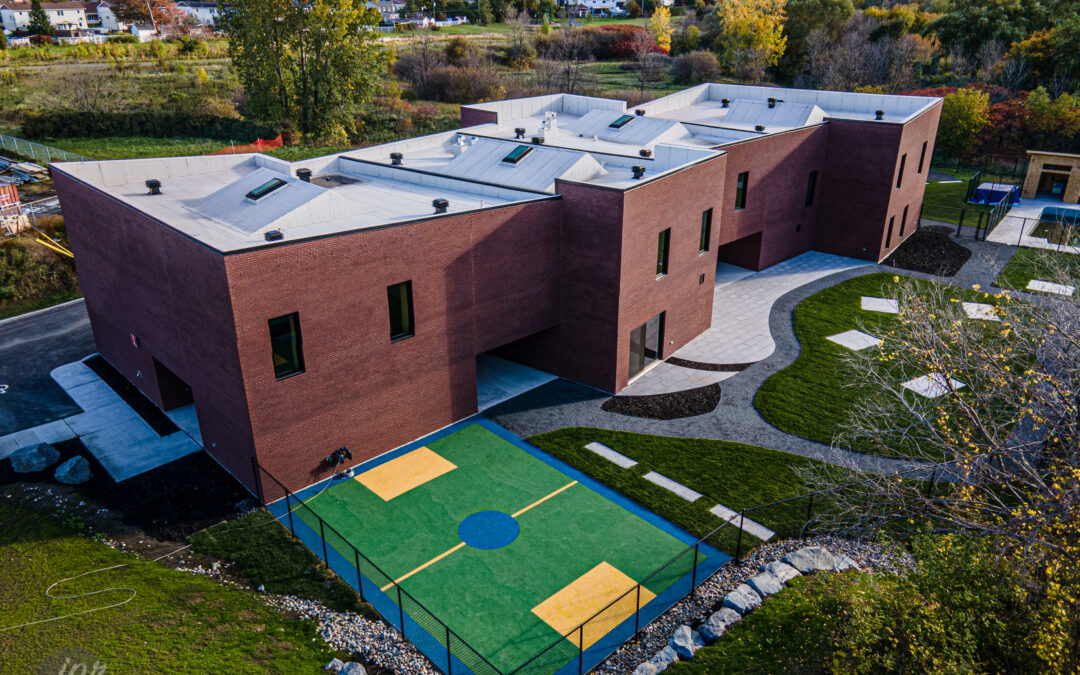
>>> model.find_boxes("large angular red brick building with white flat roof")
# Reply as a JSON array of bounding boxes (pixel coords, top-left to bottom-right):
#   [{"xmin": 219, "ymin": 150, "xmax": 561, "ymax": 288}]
[{"xmin": 53, "ymin": 84, "xmax": 941, "ymax": 488}]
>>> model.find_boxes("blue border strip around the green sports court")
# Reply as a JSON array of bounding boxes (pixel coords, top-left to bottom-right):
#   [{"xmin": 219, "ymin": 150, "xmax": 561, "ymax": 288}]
[{"xmin": 267, "ymin": 414, "xmax": 731, "ymax": 675}]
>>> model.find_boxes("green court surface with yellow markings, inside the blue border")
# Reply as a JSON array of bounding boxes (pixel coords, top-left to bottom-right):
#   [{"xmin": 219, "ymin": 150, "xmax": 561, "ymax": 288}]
[{"xmin": 294, "ymin": 423, "xmax": 704, "ymax": 673}]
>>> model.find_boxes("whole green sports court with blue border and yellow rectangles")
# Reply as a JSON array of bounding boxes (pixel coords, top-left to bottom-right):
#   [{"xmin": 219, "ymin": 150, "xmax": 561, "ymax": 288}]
[{"xmin": 271, "ymin": 418, "xmax": 728, "ymax": 673}]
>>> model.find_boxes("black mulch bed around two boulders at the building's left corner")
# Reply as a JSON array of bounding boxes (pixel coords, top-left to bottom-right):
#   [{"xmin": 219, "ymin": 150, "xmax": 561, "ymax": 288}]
[{"xmin": 0, "ymin": 438, "xmax": 248, "ymax": 541}]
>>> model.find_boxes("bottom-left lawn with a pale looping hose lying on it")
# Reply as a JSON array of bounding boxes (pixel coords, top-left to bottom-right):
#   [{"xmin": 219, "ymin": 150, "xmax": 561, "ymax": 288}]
[{"xmin": 0, "ymin": 505, "xmax": 341, "ymax": 673}]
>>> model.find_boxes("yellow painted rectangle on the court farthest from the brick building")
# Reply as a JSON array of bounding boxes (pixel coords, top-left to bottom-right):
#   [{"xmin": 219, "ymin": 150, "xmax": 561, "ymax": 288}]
[{"xmin": 532, "ymin": 563, "xmax": 656, "ymax": 649}]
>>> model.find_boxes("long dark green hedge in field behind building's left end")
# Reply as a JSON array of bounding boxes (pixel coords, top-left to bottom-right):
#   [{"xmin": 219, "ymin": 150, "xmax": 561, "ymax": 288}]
[{"xmin": 21, "ymin": 110, "xmax": 281, "ymax": 143}]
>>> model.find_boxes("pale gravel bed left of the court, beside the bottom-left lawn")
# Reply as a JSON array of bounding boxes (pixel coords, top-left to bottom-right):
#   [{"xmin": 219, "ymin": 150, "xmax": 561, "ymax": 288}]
[{"xmin": 266, "ymin": 595, "xmax": 438, "ymax": 675}]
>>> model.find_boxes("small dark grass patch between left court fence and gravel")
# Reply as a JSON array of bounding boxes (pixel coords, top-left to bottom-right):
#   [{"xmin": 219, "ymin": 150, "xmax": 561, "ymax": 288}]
[{"xmin": 188, "ymin": 510, "xmax": 376, "ymax": 617}]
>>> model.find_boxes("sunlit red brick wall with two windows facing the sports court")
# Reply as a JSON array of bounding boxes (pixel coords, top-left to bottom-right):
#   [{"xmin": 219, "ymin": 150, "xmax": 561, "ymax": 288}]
[{"xmin": 226, "ymin": 200, "xmax": 559, "ymax": 487}]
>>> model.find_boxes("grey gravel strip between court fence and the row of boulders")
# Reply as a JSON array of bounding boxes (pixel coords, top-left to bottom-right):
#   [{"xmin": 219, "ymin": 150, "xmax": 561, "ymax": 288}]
[{"xmin": 593, "ymin": 535, "xmax": 912, "ymax": 674}]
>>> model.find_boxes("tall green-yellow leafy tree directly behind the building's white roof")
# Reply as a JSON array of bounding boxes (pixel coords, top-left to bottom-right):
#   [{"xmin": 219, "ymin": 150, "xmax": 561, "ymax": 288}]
[{"xmin": 218, "ymin": 0, "xmax": 387, "ymax": 138}]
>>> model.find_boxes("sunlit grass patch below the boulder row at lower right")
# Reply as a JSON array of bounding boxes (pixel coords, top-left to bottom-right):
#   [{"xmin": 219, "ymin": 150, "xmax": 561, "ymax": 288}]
[{"xmin": 667, "ymin": 571, "xmax": 868, "ymax": 675}]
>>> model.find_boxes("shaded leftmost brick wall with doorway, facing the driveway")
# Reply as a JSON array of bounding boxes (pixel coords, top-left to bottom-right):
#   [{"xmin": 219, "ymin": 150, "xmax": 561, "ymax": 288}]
[{"xmin": 53, "ymin": 167, "xmax": 254, "ymax": 487}]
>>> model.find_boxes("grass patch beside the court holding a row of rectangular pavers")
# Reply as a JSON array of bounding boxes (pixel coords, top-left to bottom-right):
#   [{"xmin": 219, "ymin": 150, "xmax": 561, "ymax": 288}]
[{"xmin": 529, "ymin": 427, "xmax": 825, "ymax": 554}]
